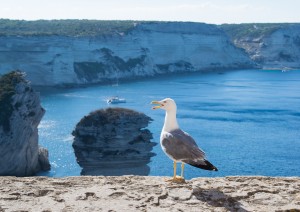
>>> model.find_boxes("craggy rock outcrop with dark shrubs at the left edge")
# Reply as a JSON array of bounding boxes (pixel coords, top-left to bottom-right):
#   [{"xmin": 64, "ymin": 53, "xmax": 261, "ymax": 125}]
[{"xmin": 0, "ymin": 71, "xmax": 50, "ymax": 176}]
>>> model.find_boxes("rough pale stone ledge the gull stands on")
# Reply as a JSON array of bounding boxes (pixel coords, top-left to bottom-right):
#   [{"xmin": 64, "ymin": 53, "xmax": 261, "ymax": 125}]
[{"xmin": 0, "ymin": 176, "xmax": 300, "ymax": 212}]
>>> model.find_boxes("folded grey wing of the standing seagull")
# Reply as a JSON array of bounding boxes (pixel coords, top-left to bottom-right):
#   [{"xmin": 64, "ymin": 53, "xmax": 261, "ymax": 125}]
[{"xmin": 161, "ymin": 129, "xmax": 205, "ymax": 162}]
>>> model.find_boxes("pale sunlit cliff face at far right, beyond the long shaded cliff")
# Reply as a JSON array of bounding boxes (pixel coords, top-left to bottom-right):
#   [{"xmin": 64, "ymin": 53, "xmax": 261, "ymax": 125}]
[{"xmin": 221, "ymin": 24, "xmax": 300, "ymax": 69}]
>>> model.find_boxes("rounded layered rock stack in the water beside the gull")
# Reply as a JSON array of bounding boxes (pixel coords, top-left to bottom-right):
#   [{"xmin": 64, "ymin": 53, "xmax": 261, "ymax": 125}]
[{"xmin": 73, "ymin": 108, "xmax": 155, "ymax": 176}]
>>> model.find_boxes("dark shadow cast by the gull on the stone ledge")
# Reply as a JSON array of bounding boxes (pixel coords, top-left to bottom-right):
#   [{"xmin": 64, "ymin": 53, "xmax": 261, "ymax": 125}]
[{"xmin": 193, "ymin": 188, "xmax": 248, "ymax": 212}]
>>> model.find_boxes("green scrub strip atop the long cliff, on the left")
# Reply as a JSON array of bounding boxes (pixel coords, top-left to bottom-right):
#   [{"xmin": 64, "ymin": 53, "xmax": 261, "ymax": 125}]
[{"xmin": 0, "ymin": 19, "xmax": 137, "ymax": 37}]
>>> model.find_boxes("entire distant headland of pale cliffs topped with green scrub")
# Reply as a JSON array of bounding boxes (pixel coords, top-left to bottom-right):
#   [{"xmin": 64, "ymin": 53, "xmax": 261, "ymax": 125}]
[{"xmin": 0, "ymin": 19, "xmax": 300, "ymax": 86}]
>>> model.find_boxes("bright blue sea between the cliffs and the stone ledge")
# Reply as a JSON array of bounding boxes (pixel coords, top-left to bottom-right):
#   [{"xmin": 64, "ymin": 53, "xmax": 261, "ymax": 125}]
[{"xmin": 36, "ymin": 70, "xmax": 300, "ymax": 179}]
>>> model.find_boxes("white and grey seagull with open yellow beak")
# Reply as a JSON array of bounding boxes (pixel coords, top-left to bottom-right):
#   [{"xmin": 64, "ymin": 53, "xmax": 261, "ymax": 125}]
[{"xmin": 151, "ymin": 98, "xmax": 218, "ymax": 182}]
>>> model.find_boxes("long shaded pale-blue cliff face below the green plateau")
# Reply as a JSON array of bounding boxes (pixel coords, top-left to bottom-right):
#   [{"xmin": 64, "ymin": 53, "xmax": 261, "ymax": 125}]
[{"xmin": 0, "ymin": 22, "xmax": 254, "ymax": 86}]
